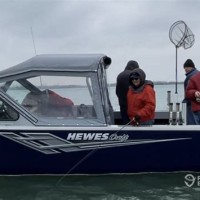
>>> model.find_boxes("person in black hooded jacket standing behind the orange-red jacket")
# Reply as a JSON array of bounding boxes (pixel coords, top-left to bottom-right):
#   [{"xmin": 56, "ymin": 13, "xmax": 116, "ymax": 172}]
[{"xmin": 116, "ymin": 60, "xmax": 139, "ymax": 124}]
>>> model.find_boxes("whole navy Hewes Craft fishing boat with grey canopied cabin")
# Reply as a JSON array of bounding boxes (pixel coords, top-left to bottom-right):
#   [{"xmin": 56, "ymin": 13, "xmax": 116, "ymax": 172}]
[{"xmin": 0, "ymin": 54, "xmax": 200, "ymax": 175}]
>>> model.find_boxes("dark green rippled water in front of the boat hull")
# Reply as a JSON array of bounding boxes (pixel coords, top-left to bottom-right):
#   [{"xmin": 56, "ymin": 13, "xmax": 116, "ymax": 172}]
[{"xmin": 0, "ymin": 173, "xmax": 200, "ymax": 200}]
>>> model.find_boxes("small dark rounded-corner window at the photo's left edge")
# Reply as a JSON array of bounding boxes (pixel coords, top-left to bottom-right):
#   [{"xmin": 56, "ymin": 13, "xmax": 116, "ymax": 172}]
[{"xmin": 0, "ymin": 98, "xmax": 19, "ymax": 121}]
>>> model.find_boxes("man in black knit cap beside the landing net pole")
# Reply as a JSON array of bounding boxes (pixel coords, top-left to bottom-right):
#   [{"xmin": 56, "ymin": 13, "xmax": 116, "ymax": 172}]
[{"xmin": 183, "ymin": 59, "xmax": 198, "ymax": 125}]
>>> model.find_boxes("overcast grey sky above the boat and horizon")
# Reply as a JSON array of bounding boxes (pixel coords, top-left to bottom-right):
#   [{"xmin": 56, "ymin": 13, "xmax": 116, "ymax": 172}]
[{"xmin": 0, "ymin": 0, "xmax": 200, "ymax": 83}]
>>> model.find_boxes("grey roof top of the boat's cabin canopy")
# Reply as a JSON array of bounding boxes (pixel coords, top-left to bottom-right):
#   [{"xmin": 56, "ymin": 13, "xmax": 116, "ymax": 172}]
[{"xmin": 0, "ymin": 54, "xmax": 111, "ymax": 81}]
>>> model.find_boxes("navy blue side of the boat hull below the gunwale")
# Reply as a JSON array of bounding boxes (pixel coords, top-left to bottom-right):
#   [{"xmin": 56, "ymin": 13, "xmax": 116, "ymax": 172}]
[{"xmin": 0, "ymin": 130, "xmax": 200, "ymax": 174}]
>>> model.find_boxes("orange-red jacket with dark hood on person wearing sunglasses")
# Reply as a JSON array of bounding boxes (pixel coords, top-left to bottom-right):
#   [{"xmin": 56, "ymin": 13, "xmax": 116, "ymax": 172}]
[{"xmin": 127, "ymin": 69, "xmax": 156, "ymax": 123}]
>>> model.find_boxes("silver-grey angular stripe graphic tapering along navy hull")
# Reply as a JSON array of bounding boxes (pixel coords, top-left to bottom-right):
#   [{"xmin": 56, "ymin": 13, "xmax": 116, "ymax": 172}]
[{"xmin": 0, "ymin": 132, "xmax": 192, "ymax": 154}]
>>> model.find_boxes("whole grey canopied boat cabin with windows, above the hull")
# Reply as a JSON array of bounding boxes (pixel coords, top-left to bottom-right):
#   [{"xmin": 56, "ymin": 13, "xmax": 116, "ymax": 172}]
[{"xmin": 0, "ymin": 54, "xmax": 114, "ymax": 126}]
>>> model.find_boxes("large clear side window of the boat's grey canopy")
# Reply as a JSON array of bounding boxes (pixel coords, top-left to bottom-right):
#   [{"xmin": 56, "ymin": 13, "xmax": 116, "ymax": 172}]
[{"xmin": 2, "ymin": 74, "xmax": 104, "ymax": 124}]
